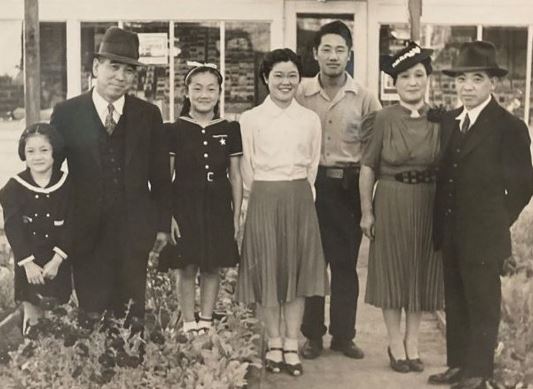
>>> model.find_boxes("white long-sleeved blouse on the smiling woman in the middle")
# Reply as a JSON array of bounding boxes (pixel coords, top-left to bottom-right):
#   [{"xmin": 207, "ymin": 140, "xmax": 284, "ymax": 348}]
[{"xmin": 240, "ymin": 96, "xmax": 322, "ymax": 196}]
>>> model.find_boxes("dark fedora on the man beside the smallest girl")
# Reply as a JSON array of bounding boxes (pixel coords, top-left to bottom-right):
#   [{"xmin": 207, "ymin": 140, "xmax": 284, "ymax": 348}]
[{"xmin": 94, "ymin": 27, "xmax": 144, "ymax": 66}]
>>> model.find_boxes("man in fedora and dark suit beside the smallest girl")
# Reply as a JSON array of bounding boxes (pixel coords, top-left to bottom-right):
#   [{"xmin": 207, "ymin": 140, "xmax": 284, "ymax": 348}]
[{"xmin": 51, "ymin": 27, "xmax": 171, "ymax": 319}]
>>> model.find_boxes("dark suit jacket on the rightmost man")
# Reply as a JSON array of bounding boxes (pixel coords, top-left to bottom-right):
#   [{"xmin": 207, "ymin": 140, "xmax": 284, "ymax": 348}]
[{"xmin": 434, "ymin": 97, "xmax": 533, "ymax": 263}]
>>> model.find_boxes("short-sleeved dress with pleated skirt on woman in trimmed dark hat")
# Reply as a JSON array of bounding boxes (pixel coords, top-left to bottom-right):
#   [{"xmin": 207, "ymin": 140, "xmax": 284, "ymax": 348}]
[{"xmin": 361, "ymin": 104, "xmax": 444, "ymax": 311}]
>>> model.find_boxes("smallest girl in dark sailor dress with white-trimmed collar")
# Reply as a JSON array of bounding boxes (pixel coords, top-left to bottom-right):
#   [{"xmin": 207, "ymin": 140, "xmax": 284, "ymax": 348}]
[{"xmin": 0, "ymin": 123, "xmax": 72, "ymax": 331}]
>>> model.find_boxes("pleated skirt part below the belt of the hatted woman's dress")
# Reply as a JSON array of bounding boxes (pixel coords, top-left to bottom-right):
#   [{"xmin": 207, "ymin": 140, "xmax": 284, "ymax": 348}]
[{"xmin": 365, "ymin": 180, "xmax": 444, "ymax": 312}]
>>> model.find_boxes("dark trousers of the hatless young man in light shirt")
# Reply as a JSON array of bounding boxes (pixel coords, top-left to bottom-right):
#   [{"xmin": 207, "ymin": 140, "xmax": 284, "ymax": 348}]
[{"xmin": 301, "ymin": 168, "xmax": 362, "ymax": 342}]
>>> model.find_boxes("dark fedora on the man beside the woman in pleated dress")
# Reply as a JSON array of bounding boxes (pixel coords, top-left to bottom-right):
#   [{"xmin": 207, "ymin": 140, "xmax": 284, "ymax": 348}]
[{"xmin": 442, "ymin": 41, "xmax": 507, "ymax": 77}]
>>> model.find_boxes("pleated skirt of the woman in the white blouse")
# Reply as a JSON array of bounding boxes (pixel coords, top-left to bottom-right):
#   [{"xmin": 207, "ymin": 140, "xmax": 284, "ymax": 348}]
[{"xmin": 236, "ymin": 179, "xmax": 329, "ymax": 307}]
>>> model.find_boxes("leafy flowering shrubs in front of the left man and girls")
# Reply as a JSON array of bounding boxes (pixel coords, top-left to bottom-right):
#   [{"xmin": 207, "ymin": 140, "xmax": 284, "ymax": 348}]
[{"xmin": 0, "ymin": 271, "xmax": 260, "ymax": 389}]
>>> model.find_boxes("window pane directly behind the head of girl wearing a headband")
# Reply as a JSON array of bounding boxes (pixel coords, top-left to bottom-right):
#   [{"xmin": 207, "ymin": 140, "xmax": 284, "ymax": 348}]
[{"xmin": 174, "ymin": 22, "xmax": 220, "ymax": 117}]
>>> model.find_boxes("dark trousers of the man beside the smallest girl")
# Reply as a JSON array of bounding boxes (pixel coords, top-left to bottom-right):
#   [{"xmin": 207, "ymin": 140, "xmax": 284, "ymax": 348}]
[{"xmin": 73, "ymin": 202, "xmax": 148, "ymax": 319}]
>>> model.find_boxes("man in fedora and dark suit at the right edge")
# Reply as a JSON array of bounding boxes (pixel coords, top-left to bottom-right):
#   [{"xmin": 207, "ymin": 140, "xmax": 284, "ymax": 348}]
[{"xmin": 429, "ymin": 41, "xmax": 533, "ymax": 389}]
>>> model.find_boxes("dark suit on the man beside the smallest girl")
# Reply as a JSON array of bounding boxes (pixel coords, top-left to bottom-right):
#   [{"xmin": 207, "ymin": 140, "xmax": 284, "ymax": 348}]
[{"xmin": 51, "ymin": 91, "xmax": 171, "ymax": 314}]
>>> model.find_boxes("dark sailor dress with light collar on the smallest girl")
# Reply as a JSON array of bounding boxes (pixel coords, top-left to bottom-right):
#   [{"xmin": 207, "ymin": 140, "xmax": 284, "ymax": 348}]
[{"xmin": 0, "ymin": 170, "xmax": 72, "ymax": 304}]
